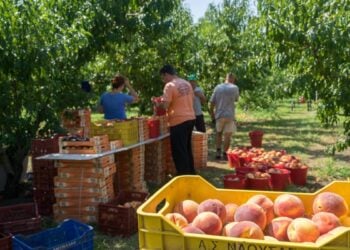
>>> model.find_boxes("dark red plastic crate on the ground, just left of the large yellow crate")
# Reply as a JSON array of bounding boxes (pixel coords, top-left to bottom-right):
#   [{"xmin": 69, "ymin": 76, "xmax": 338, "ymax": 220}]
[{"xmin": 98, "ymin": 191, "xmax": 149, "ymax": 236}]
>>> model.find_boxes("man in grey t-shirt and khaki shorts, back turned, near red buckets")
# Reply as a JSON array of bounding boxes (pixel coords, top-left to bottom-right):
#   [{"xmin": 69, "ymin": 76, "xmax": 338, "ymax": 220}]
[{"xmin": 209, "ymin": 73, "xmax": 239, "ymax": 160}]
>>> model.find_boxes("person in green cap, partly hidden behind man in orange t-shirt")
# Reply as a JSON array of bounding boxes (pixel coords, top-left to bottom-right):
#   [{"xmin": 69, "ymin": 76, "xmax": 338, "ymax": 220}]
[{"xmin": 187, "ymin": 74, "xmax": 207, "ymax": 133}]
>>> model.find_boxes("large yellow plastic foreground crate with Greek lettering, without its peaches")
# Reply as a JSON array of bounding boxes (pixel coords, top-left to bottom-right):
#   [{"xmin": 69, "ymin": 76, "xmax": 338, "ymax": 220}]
[{"xmin": 137, "ymin": 176, "xmax": 350, "ymax": 250}]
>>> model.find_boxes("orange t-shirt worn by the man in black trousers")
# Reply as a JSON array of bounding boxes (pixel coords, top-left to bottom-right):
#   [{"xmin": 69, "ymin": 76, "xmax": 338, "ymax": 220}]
[{"xmin": 163, "ymin": 78, "xmax": 195, "ymax": 127}]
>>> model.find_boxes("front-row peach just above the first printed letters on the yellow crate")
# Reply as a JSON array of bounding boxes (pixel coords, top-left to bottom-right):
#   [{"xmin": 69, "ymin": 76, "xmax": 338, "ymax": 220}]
[{"xmin": 192, "ymin": 211, "xmax": 222, "ymax": 235}]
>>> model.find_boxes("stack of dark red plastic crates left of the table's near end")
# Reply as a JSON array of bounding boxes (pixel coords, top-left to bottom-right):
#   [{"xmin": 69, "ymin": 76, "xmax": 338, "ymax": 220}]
[{"xmin": 31, "ymin": 136, "xmax": 59, "ymax": 216}]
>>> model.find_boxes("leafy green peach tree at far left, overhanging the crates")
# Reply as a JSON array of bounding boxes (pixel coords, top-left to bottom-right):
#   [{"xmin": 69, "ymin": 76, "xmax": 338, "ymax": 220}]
[{"xmin": 0, "ymin": 0, "xmax": 179, "ymax": 196}]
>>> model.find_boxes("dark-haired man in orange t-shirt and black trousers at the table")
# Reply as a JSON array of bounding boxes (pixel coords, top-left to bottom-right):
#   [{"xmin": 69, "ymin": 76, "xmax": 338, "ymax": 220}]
[{"xmin": 160, "ymin": 65, "xmax": 196, "ymax": 175}]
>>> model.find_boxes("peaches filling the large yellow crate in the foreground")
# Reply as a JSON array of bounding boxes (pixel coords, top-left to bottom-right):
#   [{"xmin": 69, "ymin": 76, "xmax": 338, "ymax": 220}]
[{"xmin": 165, "ymin": 192, "xmax": 350, "ymax": 244}]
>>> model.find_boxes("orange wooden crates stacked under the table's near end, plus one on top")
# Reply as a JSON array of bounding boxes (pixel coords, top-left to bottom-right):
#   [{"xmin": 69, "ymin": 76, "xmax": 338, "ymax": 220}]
[{"xmin": 54, "ymin": 135, "xmax": 116, "ymax": 223}]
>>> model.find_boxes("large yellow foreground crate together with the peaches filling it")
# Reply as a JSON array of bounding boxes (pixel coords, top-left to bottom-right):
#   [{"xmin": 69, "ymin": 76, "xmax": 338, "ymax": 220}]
[{"xmin": 137, "ymin": 176, "xmax": 350, "ymax": 250}]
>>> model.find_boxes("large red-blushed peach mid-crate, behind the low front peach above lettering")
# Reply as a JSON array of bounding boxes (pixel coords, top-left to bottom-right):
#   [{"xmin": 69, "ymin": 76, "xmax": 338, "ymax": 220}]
[{"xmin": 234, "ymin": 203, "xmax": 266, "ymax": 230}]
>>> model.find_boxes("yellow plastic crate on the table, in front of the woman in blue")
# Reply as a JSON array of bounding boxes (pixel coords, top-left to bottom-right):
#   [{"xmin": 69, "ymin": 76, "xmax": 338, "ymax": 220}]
[{"xmin": 90, "ymin": 119, "xmax": 139, "ymax": 146}]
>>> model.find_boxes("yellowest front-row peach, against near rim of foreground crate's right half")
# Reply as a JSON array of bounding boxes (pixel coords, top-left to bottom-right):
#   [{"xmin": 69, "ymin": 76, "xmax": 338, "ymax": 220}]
[{"xmin": 287, "ymin": 218, "xmax": 320, "ymax": 242}]
